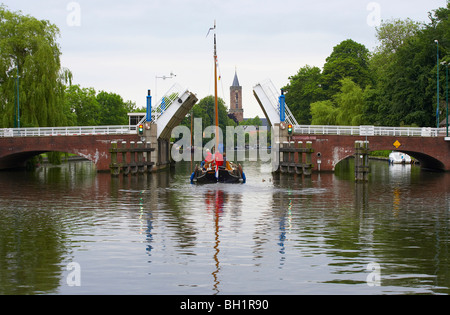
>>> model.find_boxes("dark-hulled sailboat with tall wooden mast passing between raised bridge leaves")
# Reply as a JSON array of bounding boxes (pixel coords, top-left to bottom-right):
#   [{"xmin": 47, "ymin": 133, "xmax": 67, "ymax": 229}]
[{"xmin": 191, "ymin": 21, "xmax": 246, "ymax": 184}]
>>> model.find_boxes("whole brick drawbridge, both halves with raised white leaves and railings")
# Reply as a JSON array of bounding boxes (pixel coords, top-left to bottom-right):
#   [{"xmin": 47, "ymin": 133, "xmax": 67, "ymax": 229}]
[{"xmin": 0, "ymin": 80, "xmax": 450, "ymax": 173}]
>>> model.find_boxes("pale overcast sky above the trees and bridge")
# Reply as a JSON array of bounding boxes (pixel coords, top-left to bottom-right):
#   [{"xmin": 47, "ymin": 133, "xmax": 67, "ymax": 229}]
[{"xmin": 0, "ymin": 0, "xmax": 446, "ymax": 118}]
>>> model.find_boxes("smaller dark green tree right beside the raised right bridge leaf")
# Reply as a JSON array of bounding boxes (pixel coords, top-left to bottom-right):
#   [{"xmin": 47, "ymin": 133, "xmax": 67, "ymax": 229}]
[{"xmin": 283, "ymin": 65, "xmax": 325, "ymax": 124}]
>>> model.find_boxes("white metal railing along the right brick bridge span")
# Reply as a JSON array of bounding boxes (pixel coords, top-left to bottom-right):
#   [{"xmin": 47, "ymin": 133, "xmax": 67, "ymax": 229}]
[{"xmin": 294, "ymin": 125, "xmax": 446, "ymax": 137}]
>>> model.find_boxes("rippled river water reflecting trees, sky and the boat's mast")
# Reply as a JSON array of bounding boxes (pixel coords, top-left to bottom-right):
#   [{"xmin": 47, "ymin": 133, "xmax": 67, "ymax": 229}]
[{"xmin": 0, "ymin": 162, "xmax": 450, "ymax": 294}]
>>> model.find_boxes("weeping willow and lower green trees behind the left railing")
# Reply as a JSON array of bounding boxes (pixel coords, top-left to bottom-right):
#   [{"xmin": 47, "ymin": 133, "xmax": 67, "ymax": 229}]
[{"xmin": 0, "ymin": 5, "xmax": 135, "ymax": 127}]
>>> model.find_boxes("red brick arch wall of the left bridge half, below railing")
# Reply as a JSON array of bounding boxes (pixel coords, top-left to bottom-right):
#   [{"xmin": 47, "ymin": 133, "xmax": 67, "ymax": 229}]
[{"xmin": 0, "ymin": 134, "xmax": 140, "ymax": 171}]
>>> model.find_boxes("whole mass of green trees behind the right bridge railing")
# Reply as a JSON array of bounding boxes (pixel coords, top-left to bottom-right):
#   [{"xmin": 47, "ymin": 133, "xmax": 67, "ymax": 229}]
[{"xmin": 285, "ymin": 2, "xmax": 450, "ymax": 126}]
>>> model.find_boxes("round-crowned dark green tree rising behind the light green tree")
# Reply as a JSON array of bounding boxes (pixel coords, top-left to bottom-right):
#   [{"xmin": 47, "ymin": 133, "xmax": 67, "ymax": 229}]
[{"xmin": 322, "ymin": 39, "xmax": 372, "ymax": 98}]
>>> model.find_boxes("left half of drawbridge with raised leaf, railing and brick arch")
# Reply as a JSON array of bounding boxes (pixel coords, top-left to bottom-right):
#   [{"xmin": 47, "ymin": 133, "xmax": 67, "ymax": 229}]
[{"xmin": 0, "ymin": 84, "xmax": 197, "ymax": 172}]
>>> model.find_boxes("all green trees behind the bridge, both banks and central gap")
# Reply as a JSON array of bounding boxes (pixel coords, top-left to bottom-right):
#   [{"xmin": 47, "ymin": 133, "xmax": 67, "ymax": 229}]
[{"xmin": 0, "ymin": 3, "xmax": 450, "ymax": 129}]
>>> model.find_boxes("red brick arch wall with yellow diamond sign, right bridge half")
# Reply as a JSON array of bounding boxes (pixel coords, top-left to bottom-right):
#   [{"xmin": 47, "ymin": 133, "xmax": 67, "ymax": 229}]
[{"xmin": 292, "ymin": 135, "xmax": 450, "ymax": 171}]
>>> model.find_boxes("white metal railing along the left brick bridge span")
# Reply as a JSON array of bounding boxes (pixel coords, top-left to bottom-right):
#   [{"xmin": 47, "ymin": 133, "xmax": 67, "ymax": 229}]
[{"xmin": 0, "ymin": 126, "xmax": 136, "ymax": 138}]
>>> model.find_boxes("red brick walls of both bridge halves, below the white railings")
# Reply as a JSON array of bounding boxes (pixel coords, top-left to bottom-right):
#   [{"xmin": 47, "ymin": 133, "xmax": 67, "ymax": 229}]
[{"xmin": 0, "ymin": 135, "xmax": 450, "ymax": 171}]
